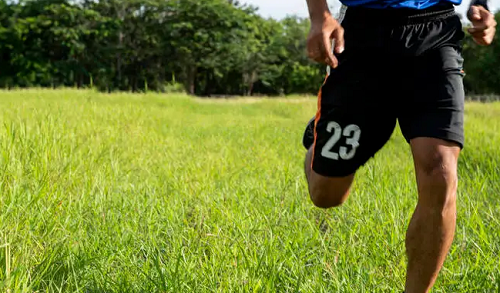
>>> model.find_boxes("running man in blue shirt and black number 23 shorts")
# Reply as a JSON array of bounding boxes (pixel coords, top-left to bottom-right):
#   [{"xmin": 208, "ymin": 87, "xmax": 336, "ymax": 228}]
[{"xmin": 303, "ymin": 0, "xmax": 496, "ymax": 293}]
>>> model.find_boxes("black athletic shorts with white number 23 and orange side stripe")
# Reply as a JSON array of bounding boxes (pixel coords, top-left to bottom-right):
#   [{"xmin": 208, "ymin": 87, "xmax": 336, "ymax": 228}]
[{"xmin": 312, "ymin": 5, "xmax": 464, "ymax": 177}]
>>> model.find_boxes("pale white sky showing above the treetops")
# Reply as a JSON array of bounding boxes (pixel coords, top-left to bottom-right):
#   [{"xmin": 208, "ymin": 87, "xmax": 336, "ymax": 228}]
[{"xmin": 245, "ymin": 0, "xmax": 500, "ymax": 19}]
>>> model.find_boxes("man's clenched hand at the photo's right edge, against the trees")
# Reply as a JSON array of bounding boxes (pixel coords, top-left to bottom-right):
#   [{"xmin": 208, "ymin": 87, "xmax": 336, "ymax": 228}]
[{"xmin": 467, "ymin": 5, "xmax": 497, "ymax": 46}]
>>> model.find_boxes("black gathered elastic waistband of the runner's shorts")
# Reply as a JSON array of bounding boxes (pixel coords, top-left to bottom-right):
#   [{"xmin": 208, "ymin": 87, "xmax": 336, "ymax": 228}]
[{"xmin": 345, "ymin": 4, "xmax": 456, "ymax": 25}]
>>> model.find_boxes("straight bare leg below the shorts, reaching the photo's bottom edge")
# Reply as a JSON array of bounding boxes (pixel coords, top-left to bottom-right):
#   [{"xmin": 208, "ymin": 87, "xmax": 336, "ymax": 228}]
[{"xmin": 406, "ymin": 138, "xmax": 460, "ymax": 293}]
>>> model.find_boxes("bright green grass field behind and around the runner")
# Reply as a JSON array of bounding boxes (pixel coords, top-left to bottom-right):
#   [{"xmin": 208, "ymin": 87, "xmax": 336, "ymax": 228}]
[{"xmin": 0, "ymin": 90, "xmax": 500, "ymax": 293}]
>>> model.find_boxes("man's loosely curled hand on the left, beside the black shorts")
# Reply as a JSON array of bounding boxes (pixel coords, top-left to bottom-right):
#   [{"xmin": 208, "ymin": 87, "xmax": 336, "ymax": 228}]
[{"xmin": 307, "ymin": 15, "xmax": 344, "ymax": 68}]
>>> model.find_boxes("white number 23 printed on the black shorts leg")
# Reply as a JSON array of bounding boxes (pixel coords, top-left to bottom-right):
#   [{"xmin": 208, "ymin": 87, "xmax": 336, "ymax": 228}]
[{"xmin": 321, "ymin": 121, "xmax": 361, "ymax": 160}]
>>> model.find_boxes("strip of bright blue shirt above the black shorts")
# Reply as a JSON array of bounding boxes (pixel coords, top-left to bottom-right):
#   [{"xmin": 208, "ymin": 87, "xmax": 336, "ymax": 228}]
[{"xmin": 340, "ymin": 0, "xmax": 462, "ymax": 9}]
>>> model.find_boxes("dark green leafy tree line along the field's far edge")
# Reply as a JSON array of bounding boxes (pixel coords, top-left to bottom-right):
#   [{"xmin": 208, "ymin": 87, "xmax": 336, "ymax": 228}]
[{"xmin": 0, "ymin": 0, "xmax": 500, "ymax": 96}]
